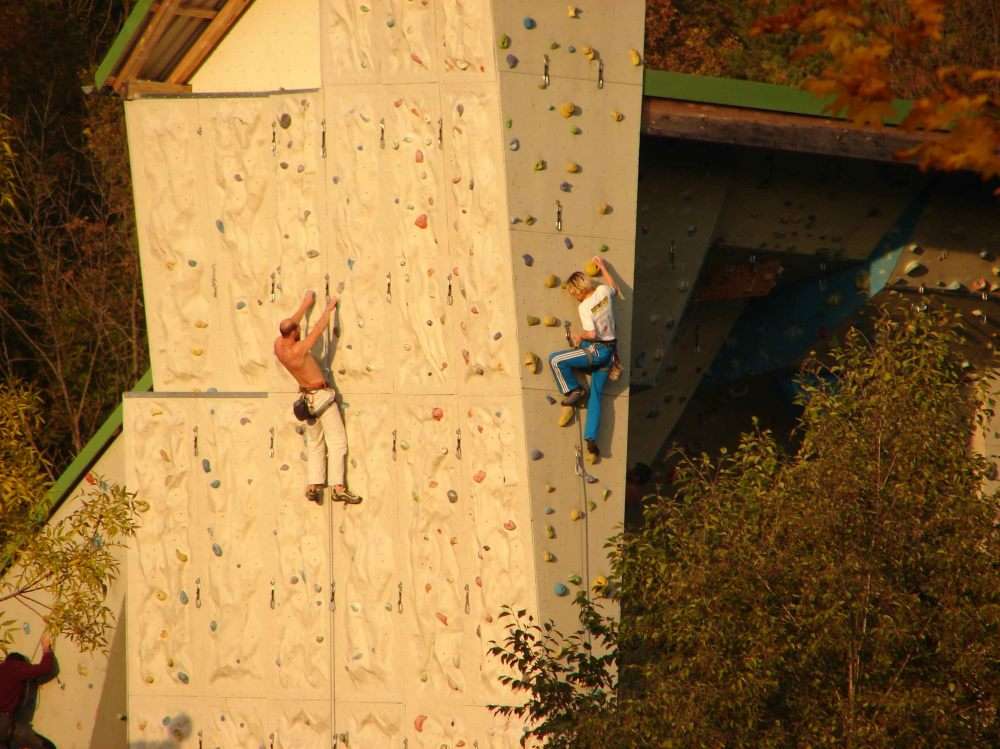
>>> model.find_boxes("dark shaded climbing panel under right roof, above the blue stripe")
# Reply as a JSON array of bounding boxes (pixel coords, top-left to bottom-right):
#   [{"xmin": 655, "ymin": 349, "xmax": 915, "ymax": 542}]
[{"xmin": 718, "ymin": 153, "xmax": 912, "ymax": 260}]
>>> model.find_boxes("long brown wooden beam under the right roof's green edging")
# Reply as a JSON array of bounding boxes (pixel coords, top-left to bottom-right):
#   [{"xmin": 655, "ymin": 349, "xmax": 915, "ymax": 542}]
[{"xmin": 642, "ymin": 98, "xmax": 941, "ymax": 162}]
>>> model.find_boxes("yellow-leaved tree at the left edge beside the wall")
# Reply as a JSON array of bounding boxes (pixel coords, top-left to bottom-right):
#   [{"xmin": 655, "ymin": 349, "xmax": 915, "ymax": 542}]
[{"xmin": 0, "ymin": 382, "xmax": 145, "ymax": 651}]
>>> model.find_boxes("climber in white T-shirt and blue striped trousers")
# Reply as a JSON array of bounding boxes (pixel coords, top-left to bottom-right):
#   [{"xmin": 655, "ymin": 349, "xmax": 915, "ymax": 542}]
[{"xmin": 549, "ymin": 257, "xmax": 620, "ymax": 457}]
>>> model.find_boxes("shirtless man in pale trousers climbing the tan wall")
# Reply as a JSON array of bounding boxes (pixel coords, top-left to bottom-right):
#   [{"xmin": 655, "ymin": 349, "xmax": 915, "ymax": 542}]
[{"xmin": 274, "ymin": 291, "xmax": 361, "ymax": 505}]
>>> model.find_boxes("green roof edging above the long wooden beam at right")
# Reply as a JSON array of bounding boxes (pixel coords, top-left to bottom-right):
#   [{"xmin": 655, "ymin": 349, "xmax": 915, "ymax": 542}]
[{"xmin": 643, "ymin": 70, "xmax": 912, "ymax": 124}]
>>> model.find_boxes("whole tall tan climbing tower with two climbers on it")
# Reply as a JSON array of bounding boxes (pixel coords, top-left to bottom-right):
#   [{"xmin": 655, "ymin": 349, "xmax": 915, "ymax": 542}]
[{"xmin": 126, "ymin": 0, "xmax": 644, "ymax": 749}]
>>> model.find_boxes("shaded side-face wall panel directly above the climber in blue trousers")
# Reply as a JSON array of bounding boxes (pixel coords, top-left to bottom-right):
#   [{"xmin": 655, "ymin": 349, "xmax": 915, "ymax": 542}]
[{"xmin": 501, "ymin": 74, "xmax": 642, "ymax": 242}]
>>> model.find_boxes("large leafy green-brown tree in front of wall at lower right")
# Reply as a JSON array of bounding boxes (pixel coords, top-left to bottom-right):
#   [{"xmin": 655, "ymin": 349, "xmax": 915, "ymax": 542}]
[{"xmin": 496, "ymin": 312, "xmax": 1000, "ymax": 749}]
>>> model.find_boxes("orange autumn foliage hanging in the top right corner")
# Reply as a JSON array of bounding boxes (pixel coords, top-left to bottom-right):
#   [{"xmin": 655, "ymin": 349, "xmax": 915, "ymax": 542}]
[{"xmin": 755, "ymin": 0, "xmax": 1000, "ymax": 186}]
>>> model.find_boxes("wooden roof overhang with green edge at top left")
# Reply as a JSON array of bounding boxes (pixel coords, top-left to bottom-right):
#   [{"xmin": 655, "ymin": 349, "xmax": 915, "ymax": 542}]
[{"xmin": 94, "ymin": 0, "xmax": 253, "ymax": 97}]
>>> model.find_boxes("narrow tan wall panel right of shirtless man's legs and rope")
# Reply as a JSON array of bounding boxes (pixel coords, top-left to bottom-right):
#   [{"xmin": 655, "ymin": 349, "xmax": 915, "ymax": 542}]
[{"xmin": 333, "ymin": 395, "xmax": 405, "ymax": 701}]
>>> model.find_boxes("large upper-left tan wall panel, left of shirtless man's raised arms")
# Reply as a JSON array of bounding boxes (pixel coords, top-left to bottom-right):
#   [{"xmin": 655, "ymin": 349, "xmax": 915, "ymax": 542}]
[{"xmin": 128, "ymin": 94, "xmax": 327, "ymax": 390}]
